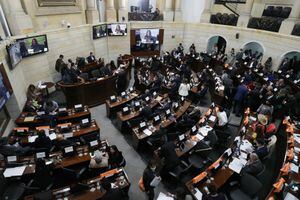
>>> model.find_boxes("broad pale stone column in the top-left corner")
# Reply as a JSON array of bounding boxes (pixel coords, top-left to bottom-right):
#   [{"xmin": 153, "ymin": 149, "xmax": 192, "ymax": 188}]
[{"xmin": 1, "ymin": 0, "xmax": 34, "ymax": 35}]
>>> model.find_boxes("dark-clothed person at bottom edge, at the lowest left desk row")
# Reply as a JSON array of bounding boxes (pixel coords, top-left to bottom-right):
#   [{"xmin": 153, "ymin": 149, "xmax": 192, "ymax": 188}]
[{"xmin": 101, "ymin": 181, "xmax": 128, "ymax": 200}]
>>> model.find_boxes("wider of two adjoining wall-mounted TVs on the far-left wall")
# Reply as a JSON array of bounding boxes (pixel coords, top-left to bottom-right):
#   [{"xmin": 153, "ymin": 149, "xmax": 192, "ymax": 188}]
[{"xmin": 17, "ymin": 35, "xmax": 49, "ymax": 57}]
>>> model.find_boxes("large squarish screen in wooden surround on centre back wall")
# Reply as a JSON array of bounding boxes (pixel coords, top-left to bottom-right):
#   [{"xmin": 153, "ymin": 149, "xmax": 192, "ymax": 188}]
[{"xmin": 134, "ymin": 29, "xmax": 160, "ymax": 51}]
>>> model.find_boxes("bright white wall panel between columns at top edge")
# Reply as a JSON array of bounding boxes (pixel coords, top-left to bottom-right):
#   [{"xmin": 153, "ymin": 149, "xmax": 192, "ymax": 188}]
[{"xmin": 181, "ymin": 0, "xmax": 205, "ymax": 23}]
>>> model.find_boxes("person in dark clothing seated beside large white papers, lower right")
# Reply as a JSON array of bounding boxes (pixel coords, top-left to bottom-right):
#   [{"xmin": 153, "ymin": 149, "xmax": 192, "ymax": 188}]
[{"xmin": 242, "ymin": 153, "xmax": 263, "ymax": 176}]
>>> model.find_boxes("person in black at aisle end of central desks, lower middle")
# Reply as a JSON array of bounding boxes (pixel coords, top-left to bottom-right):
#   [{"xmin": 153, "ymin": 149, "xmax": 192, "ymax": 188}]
[{"xmin": 160, "ymin": 139, "xmax": 180, "ymax": 171}]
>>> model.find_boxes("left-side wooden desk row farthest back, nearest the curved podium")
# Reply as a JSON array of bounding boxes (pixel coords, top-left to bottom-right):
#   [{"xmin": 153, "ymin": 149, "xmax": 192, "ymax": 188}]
[{"xmin": 15, "ymin": 106, "xmax": 91, "ymax": 127}]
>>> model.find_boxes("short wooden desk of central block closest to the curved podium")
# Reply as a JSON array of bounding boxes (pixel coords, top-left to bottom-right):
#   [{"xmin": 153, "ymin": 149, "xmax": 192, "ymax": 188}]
[{"xmin": 105, "ymin": 91, "xmax": 140, "ymax": 118}]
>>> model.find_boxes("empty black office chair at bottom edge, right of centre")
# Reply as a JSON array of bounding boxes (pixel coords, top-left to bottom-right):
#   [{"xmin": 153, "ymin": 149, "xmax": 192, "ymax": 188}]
[{"xmin": 230, "ymin": 173, "xmax": 262, "ymax": 200}]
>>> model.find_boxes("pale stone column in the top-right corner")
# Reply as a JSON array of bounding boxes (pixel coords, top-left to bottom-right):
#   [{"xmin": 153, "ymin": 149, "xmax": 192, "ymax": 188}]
[{"xmin": 279, "ymin": 0, "xmax": 300, "ymax": 35}]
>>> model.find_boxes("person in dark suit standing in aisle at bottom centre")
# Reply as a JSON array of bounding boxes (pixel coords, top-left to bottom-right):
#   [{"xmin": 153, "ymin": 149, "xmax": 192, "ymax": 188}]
[{"xmin": 143, "ymin": 160, "xmax": 159, "ymax": 200}]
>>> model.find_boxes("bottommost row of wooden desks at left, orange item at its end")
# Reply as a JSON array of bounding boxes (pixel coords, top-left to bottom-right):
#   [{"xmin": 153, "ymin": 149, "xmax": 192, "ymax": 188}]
[{"xmin": 24, "ymin": 168, "xmax": 130, "ymax": 200}]
